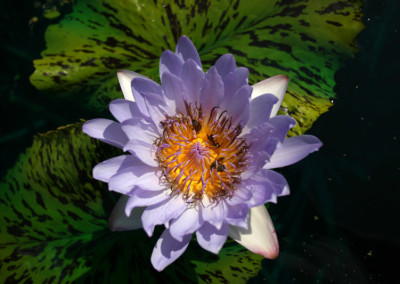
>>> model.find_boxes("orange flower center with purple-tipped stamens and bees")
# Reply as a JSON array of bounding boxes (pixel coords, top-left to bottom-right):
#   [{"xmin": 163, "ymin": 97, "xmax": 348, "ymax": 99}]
[{"xmin": 155, "ymin": 105, "xmax": 248, "ymax": 201}]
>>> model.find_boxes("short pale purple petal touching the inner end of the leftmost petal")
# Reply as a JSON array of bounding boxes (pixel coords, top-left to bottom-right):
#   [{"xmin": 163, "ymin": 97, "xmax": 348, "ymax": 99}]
[{"xmin": 122, "ymin": 117, "xmax": 160, "ymax": 144}]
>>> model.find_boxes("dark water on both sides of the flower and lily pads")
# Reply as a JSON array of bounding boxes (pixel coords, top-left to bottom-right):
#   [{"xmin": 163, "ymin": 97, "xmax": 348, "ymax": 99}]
[{"xmin": 0, "ymin": 0, "xmax": 400, "ymax": 283}]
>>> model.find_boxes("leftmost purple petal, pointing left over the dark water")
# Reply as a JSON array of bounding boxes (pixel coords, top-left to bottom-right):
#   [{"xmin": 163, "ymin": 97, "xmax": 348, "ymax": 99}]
[{"xmin": 82, "ymin": 118, "xmax": 128, "ymax": 148}]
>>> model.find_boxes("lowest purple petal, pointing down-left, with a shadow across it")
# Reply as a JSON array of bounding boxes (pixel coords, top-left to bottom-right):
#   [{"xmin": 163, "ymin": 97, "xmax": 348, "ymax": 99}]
[{"xmin": 151, "ymin": 227, "xmax": 192, "ymax": 271}]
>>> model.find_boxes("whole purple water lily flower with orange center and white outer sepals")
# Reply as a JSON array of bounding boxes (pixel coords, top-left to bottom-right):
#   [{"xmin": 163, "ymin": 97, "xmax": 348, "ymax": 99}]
[{"xmin": 83, "ymin": 36, "xmax": 321, "ymax": 271}]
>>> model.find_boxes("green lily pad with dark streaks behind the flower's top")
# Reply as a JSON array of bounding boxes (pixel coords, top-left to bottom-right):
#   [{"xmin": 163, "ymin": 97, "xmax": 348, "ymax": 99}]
[{"xmin": 30, "ymin": 0, "xmax": 363, "ymax": 135}]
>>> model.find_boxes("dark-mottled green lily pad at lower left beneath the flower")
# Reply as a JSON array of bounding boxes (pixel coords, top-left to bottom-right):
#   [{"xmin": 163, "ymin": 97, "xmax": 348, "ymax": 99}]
[{"xmin": 0, "ymin": 123, "xmax": 263, "ymax": 283}]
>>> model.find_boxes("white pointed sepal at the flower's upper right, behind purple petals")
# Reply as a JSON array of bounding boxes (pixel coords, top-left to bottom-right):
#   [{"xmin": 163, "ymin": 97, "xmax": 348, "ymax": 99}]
[{"xmin": 251, "ymin": 75, "xmax": 289, "ymax": 117}]
